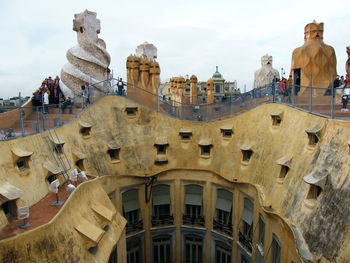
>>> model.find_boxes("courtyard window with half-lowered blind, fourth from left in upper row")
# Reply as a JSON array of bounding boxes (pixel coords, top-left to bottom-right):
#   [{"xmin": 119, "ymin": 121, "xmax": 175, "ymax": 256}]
[{"xmin": 213, "ymin": 189, "xmax": 232, "ymax": 235}]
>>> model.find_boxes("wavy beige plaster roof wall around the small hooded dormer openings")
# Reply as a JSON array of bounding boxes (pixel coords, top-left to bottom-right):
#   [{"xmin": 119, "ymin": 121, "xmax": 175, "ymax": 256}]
[{"xmin": 0, "ymin": 97, "xmax": 350, "ymax": 263}]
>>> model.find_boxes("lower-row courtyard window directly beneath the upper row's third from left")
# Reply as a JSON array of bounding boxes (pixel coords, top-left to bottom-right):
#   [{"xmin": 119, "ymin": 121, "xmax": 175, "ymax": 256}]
[{"xmin": 185, "ymin": 236, "xmax": 203, "ymax": 263}]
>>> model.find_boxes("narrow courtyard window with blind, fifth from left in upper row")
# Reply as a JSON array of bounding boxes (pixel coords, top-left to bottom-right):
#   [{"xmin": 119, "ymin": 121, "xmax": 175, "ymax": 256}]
[{"xmin": 239, "ymin": 197, "xmax": 254, "ymax": 252}]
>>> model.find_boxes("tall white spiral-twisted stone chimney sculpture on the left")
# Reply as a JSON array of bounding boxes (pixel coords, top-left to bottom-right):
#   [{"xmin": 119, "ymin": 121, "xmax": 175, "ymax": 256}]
[{"xmin": 61, "ymin": 10, "xmax": 111, "ymax": 97}]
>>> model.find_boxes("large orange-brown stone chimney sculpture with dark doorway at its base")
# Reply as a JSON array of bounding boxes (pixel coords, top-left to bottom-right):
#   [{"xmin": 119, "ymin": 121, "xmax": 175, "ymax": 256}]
[{"xmin": 290, "ymin": 21, "xmax": 337, "ymax": 95}]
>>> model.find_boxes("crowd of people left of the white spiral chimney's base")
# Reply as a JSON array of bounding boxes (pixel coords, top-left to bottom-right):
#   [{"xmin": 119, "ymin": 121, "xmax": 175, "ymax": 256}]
[{"xmin": 32, "ymin": 76, "xmax": 62, "ymax": 113}]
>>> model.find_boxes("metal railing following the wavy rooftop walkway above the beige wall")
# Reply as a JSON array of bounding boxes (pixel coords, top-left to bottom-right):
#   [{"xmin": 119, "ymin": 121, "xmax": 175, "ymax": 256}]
[{"xmin": 0, "ymin": 79, "xmax": 350, "ymax": 141}]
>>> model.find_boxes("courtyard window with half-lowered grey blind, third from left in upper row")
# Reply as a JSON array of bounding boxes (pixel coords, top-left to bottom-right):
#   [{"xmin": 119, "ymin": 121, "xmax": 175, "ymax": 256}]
[{"xmin": 183, "ymin": 185, "xmax": 204, "ymax": 226}]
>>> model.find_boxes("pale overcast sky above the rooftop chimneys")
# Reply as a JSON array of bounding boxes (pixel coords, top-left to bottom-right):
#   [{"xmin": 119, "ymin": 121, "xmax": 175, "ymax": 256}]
[{"xmin": 0, "ymin": 0, "xmax": 350, "ymax": 98}]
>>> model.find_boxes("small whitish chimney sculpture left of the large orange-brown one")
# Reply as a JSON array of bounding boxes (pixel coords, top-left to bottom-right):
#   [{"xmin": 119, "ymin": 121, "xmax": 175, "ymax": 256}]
[{"xmin": 254, "ymin": 54, "xmax": 280, "ymax": 89}]
